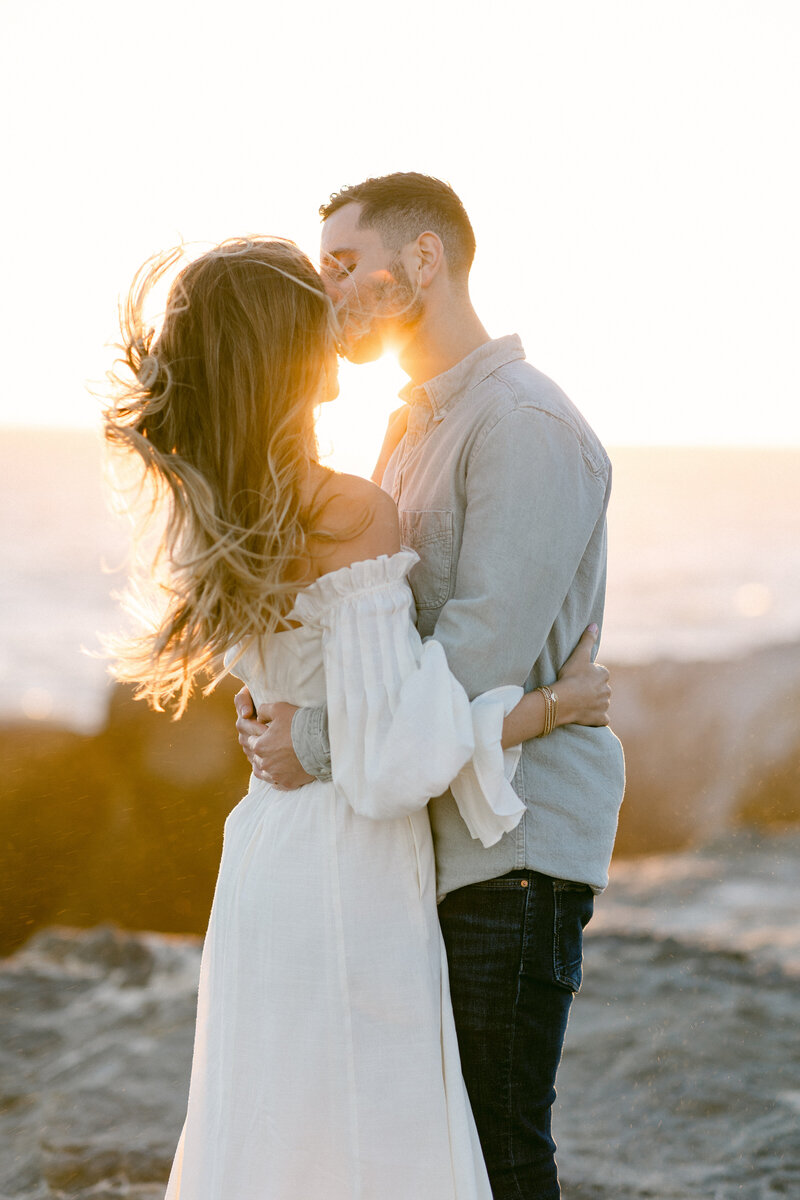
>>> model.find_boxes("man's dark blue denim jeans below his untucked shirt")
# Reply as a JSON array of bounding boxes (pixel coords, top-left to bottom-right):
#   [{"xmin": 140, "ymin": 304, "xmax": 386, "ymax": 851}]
[{"xmin": 439, "ymin": 871, "xmax": 594, "ymax": 1200}]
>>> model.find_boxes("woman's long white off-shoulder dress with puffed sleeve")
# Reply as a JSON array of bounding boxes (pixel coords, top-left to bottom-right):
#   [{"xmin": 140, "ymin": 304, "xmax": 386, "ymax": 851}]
[{"xmin": 167, "ymin": 551, "xmax": 523, "ymax": 1200}]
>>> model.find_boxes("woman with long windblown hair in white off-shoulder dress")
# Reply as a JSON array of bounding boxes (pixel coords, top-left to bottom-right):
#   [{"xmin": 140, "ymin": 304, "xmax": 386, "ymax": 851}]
[{"xmin": 106, "ymin": 239, "xmax": 608, "ymax": 1200}]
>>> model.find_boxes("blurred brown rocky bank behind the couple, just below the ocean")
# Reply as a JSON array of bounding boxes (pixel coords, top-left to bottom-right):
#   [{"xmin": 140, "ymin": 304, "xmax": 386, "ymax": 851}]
[{"xmin": 0, "ymin": 646, "xmax": 800, "ymax": 950}]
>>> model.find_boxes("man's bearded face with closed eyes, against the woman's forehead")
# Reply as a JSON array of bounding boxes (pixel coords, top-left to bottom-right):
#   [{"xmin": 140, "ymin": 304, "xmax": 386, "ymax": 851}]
[{"xmin": 320, "ymin": 203, "xmax": 422, "ymax": 362}]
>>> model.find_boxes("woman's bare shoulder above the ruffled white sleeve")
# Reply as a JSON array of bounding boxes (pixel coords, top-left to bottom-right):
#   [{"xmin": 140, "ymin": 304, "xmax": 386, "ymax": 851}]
[{"xmin": 311, "ymin": 472, "xmax": 401, "ymax": 575}]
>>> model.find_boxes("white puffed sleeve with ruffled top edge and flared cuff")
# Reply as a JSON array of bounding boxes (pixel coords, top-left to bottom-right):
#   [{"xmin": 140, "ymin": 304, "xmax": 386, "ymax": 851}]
[{"xmin": 293, "ymin": 551, "xmax": 524, "ymax": 845}]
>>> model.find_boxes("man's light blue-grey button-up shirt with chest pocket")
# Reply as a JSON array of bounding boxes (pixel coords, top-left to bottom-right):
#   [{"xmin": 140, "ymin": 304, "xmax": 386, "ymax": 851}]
[{"xmin": 291, "ymin": 336, "xmax": 625, "ymax": 895}]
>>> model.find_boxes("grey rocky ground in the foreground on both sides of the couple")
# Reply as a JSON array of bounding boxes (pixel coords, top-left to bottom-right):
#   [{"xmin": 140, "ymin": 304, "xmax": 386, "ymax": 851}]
[{"xmin": 0, "ymin": 864, "xmax": 800, "ymax": 1200}]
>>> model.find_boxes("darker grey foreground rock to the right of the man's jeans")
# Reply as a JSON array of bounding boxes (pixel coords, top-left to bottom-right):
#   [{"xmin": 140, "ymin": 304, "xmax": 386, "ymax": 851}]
[{"xmin": 554, "ymin": 926, "xmax": 800, "ymax": 1200}]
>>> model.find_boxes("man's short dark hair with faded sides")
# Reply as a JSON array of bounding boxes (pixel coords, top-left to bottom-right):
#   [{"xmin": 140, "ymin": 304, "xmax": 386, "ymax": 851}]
[{"xmin": 319, "ymin": 170, "xmax": 475, "ymax": 276}]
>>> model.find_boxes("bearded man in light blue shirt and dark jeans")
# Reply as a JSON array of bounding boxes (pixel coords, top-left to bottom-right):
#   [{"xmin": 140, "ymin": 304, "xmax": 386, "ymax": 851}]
[{"xmin": 237, "ymin": 173, "xmax": 624, "ymax": 1200}]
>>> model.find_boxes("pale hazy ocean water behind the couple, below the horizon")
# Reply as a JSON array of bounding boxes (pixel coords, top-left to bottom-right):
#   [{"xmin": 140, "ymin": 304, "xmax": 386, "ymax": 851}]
[{"xmin": 0, "ymin": 430, "xmax": 800, "ymax": 732}]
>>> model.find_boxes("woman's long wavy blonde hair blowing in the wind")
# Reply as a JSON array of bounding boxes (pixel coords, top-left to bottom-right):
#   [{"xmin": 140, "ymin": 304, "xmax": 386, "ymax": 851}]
[{"xmin": 103, "ymin": 238, "xmax": 336, "ymax": 716}]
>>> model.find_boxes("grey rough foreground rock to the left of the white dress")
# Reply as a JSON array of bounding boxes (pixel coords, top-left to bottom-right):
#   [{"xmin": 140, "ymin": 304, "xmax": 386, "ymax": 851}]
[{"xmin": 0, "ymin": 928, "xmax": 199, "ymax": 1200}]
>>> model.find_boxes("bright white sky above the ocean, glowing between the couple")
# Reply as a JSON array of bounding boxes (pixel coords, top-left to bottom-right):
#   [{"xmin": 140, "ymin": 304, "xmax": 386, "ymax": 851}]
[{"xmin": 0, "ymin": 0, "xmax": 800, "ymax": 469}]
